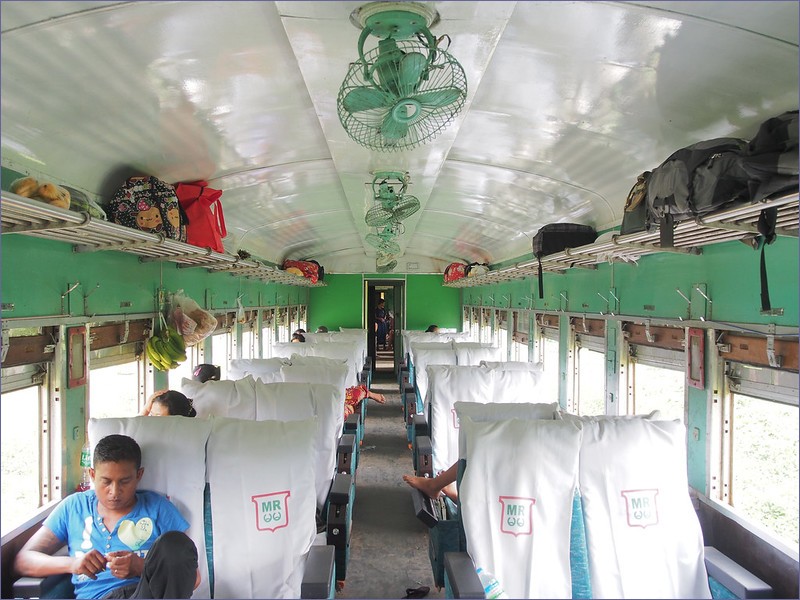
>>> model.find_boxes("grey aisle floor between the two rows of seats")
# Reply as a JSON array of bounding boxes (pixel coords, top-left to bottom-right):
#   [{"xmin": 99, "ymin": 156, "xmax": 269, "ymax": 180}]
[{"xmin": 336, "ymin": 373, "xmax": 444, "ymax": 598}]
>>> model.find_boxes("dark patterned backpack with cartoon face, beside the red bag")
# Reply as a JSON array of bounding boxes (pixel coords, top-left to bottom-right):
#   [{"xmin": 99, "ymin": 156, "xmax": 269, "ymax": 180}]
[{"xmin": 108, "ymin": 176, "xmax": 187, "ymax": 242}]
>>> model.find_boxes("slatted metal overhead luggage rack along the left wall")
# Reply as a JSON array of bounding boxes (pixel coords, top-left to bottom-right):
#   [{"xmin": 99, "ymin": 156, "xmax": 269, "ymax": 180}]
[{"xmin": 0, "ymin": 191, "xmax": 325, "ymax": 287}]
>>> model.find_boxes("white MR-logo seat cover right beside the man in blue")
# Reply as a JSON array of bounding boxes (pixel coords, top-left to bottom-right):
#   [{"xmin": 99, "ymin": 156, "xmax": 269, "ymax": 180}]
[{"xmin": 207, "ymin": 418, "xmax": 318, "ymax": 598}]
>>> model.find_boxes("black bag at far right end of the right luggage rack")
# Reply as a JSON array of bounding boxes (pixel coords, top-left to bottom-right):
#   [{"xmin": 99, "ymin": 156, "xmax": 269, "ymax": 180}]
[{"xmin": 742, "ymin": 110, "xmax": 800, "ymax": 202}]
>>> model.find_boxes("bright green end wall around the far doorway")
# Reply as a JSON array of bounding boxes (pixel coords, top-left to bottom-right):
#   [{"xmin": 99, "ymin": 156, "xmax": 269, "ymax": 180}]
[{"xmin": 308, "ymin": 274, "xmax": 461, "ymax": 331}]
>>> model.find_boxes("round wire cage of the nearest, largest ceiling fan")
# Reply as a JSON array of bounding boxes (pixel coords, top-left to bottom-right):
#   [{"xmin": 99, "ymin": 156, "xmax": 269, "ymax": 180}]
[{"xmin": 337, "ymin": 40, "xmax": 467, "ymax": 151}]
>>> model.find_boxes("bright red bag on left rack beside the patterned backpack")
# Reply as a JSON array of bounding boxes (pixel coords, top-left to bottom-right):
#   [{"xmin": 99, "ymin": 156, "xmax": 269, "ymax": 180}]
[{"xmin": 175, "ymin": 181, "xmax": 228, "ymax": 253}]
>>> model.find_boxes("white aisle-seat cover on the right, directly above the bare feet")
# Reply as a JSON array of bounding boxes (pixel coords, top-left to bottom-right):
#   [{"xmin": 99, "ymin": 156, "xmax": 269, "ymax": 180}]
[{"xmin": 425, "ymin": 365, "xmax": 494, "ymax": 475}]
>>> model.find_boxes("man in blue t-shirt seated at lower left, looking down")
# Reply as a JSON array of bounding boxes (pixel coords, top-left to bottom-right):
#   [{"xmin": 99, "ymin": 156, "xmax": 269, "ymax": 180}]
[{"xmin": 14, "ymin": 435, "xmax": 200, "ymax": 598}]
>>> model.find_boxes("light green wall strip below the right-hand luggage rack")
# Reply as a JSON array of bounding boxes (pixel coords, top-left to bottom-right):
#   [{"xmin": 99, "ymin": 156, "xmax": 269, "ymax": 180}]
[{"xmin": 463, "ymin": 238, "xmax": 800, "ymax": 326}]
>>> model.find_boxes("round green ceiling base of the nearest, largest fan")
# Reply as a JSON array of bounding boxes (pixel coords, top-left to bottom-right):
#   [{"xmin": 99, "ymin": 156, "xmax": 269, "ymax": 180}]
[{"xmin": 350, "ymin": 2, "xmax": 439, "ymax": 40}]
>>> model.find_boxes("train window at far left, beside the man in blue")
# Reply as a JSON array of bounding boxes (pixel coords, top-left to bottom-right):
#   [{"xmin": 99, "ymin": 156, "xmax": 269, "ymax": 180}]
[{"xmin": 0, "ymin": 380, "xmax": 49, "ymax": 535}]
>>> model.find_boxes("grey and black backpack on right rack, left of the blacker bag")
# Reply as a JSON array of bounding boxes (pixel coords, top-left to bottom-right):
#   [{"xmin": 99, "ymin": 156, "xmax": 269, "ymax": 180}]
[{"xmin": 647, "ymin": 138, "xmax": 750, "ymax": 248}]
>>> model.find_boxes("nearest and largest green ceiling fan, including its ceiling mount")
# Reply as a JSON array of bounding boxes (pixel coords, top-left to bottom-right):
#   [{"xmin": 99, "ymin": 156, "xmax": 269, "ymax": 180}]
[{"xmin": 337, "ymin": 2, "xmax": 467, "ymax": 151}]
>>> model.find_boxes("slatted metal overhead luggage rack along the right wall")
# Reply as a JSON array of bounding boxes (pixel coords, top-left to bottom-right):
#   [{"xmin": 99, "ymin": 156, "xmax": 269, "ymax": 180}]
[{"xmin": 444, "ymin": 192, "xmax": 800, "ymax": 288}]
